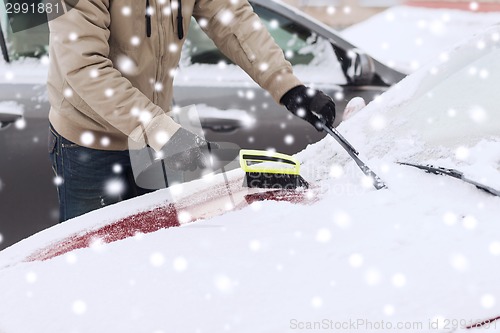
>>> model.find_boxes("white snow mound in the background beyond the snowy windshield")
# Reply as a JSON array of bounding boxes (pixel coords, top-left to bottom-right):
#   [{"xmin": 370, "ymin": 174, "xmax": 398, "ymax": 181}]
[{"xmin": 342, "ymin": 6, "xmax": 500, "ymax": 73}]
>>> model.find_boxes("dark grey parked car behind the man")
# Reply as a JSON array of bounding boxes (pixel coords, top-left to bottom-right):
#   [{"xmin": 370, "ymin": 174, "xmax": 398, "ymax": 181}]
[{"xmin": 0, "ymin": 0, "xmax": 404, "ymax": 249}]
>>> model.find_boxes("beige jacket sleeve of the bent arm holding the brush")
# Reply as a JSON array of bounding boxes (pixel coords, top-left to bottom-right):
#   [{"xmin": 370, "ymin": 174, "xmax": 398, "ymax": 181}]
[{"xmin": 49, "ymin": 0, "xmax": 180, "ymax": 151}]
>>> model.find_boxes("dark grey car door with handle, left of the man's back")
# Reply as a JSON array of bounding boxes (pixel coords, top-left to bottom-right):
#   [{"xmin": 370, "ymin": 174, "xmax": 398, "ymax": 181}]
[{"xmin": 0, "ymin": 7, "xmax": 58, "ymax": 250}]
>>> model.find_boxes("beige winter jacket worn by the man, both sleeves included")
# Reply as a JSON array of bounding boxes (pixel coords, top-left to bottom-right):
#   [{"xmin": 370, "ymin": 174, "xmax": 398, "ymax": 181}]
[{"xmin": 47, "ymin": 0, "xmax": 301, "ymax": 151}]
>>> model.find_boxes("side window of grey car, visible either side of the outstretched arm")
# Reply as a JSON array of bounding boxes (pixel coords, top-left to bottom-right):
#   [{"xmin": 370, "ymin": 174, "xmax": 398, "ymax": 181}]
[{"xmin": 183, "ymin": 5, "xmax": 322, "ymax": 66}]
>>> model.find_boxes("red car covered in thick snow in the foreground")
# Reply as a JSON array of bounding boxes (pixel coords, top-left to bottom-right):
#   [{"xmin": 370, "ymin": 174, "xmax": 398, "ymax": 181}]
[{"xmin": 0, "ymin": 19, "xmax": 500, "ymax": 333}]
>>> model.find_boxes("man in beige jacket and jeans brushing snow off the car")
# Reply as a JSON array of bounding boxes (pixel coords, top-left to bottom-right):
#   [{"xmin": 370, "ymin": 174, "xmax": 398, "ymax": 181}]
[{"xmin": 47, "ymin": 0, "xmax": 335, "ymax": 221}]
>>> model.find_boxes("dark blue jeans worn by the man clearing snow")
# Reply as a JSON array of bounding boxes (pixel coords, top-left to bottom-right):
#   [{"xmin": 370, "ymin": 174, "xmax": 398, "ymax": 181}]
[{"xmin": 48, "ymin": 126, "xmax": 152, "ymax": 222}]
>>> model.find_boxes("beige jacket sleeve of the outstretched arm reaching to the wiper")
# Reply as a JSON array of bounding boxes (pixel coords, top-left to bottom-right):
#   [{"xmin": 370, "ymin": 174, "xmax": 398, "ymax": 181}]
[{"xmin": 193, "ymin": 0, "xmax": 302, "ymax": 103}]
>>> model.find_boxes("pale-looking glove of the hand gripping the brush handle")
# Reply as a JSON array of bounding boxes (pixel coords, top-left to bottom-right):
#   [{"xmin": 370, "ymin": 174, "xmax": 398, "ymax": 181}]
[{"xmin": 161, "ymin": 127, "xmax": 215, "ymax": 171}]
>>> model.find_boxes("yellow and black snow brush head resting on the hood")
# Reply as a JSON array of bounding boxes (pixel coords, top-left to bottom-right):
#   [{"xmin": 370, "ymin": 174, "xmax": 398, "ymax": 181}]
[{"xmin": 240, "ymin": 149, "xmax": 309, "ymax": 190}]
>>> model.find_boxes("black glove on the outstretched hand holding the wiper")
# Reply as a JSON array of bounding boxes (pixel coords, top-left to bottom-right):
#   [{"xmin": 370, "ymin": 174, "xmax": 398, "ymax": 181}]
[{"xmin": 280, "ymin": 86, "xmax": 335, "ymax": 131}]
